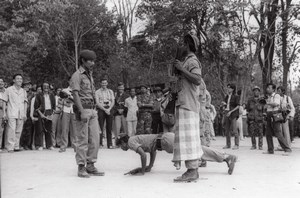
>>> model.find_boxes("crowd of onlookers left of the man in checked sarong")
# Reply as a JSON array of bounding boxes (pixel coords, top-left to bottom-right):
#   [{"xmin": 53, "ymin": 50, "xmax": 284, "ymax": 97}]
[{"xmin": 0, "ymin": 74, "xmax": 180, "ymax": 152}]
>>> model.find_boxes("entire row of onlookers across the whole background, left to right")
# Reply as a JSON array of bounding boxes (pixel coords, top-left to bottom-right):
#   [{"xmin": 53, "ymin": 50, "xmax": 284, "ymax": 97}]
[{"xmin": 0, "ymin": 74, "xmax": 300, "ymax": 153}]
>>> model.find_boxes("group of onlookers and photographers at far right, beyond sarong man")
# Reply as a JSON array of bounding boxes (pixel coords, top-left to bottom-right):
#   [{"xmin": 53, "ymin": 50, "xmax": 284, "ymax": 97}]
[{"xmin": 215, "ymin": 83, "xmax": 299, "ymax": 154}]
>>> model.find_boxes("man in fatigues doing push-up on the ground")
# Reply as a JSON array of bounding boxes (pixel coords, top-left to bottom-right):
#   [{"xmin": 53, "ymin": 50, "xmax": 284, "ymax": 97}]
[{"xmin": 117, "ymin": 132, "xmax": 237, "ymax": 175}]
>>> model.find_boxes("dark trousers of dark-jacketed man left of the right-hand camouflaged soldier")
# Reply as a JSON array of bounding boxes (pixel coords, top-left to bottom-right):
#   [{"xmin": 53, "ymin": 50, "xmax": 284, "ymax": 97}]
[{"xmin": 224, "ymin": 116, "xmax": 240, "ymax": 148}]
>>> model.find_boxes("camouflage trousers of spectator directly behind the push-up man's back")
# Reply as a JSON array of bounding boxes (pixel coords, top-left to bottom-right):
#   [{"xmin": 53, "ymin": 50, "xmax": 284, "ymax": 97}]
[{"xmin": 136, "ymin": 112, "xmax": 152, "ymax": 135}]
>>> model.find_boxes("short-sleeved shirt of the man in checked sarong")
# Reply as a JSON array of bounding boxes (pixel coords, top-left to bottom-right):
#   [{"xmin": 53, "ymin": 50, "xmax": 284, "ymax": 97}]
[{"xmin": 176, "ymin": 54, "xmax": 201, "ymax": 113}]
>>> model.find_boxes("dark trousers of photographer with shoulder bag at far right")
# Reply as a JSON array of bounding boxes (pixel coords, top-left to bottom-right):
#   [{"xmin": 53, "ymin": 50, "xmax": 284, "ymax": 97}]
[{"xmin": 266, "ymin": 113, "xmax": 291, "ymax": 152}]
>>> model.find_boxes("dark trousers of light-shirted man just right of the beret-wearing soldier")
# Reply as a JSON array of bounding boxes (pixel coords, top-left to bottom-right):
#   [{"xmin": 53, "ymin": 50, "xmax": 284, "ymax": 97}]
[{"xmin": 98, "ymin": 109, "xmax": 113, "ymax": 147}]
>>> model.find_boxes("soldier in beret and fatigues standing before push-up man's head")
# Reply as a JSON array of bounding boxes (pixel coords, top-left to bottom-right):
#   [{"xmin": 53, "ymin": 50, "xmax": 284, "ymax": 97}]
[{"xmin": 70, "ymin": 50, "xmax": 104, "ymax": 178}]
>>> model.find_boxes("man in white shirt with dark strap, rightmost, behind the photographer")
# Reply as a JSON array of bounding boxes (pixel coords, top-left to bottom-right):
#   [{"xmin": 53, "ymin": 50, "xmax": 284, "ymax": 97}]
[{"xmin": 277, "ymin": 86, "xmax": 295, "ymax": 147}]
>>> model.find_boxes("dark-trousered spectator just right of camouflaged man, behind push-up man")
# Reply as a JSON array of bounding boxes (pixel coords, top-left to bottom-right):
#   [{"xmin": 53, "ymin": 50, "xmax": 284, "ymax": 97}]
[{"xmin": 151, "ymin": 87, "xmax": 163, "ymax": 134}]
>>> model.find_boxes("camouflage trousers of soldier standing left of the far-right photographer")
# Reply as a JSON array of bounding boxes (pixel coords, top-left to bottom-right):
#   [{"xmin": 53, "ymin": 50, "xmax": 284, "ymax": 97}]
[{"xmin": 248, "ymin": 121, "xmax": 264, "ymax": 148}]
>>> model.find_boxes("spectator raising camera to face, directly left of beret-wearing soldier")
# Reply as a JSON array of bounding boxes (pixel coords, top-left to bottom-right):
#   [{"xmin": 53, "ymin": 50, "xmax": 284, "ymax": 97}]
[{"xmin": 59, "ymin": 83, "xmax": 76, "ymax": 153}]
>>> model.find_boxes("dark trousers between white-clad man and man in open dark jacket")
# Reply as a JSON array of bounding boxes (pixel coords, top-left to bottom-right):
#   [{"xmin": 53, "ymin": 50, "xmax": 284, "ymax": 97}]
[{"xmin": 20, "ymin": 118, "xmax": 34, "ymax": 148}]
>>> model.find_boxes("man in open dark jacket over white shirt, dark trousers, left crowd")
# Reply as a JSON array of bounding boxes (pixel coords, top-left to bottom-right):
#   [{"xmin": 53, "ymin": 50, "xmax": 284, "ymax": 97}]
[{"xmin": 34, "ymin": 82, "xmax": 56, "ymax": 151}]
